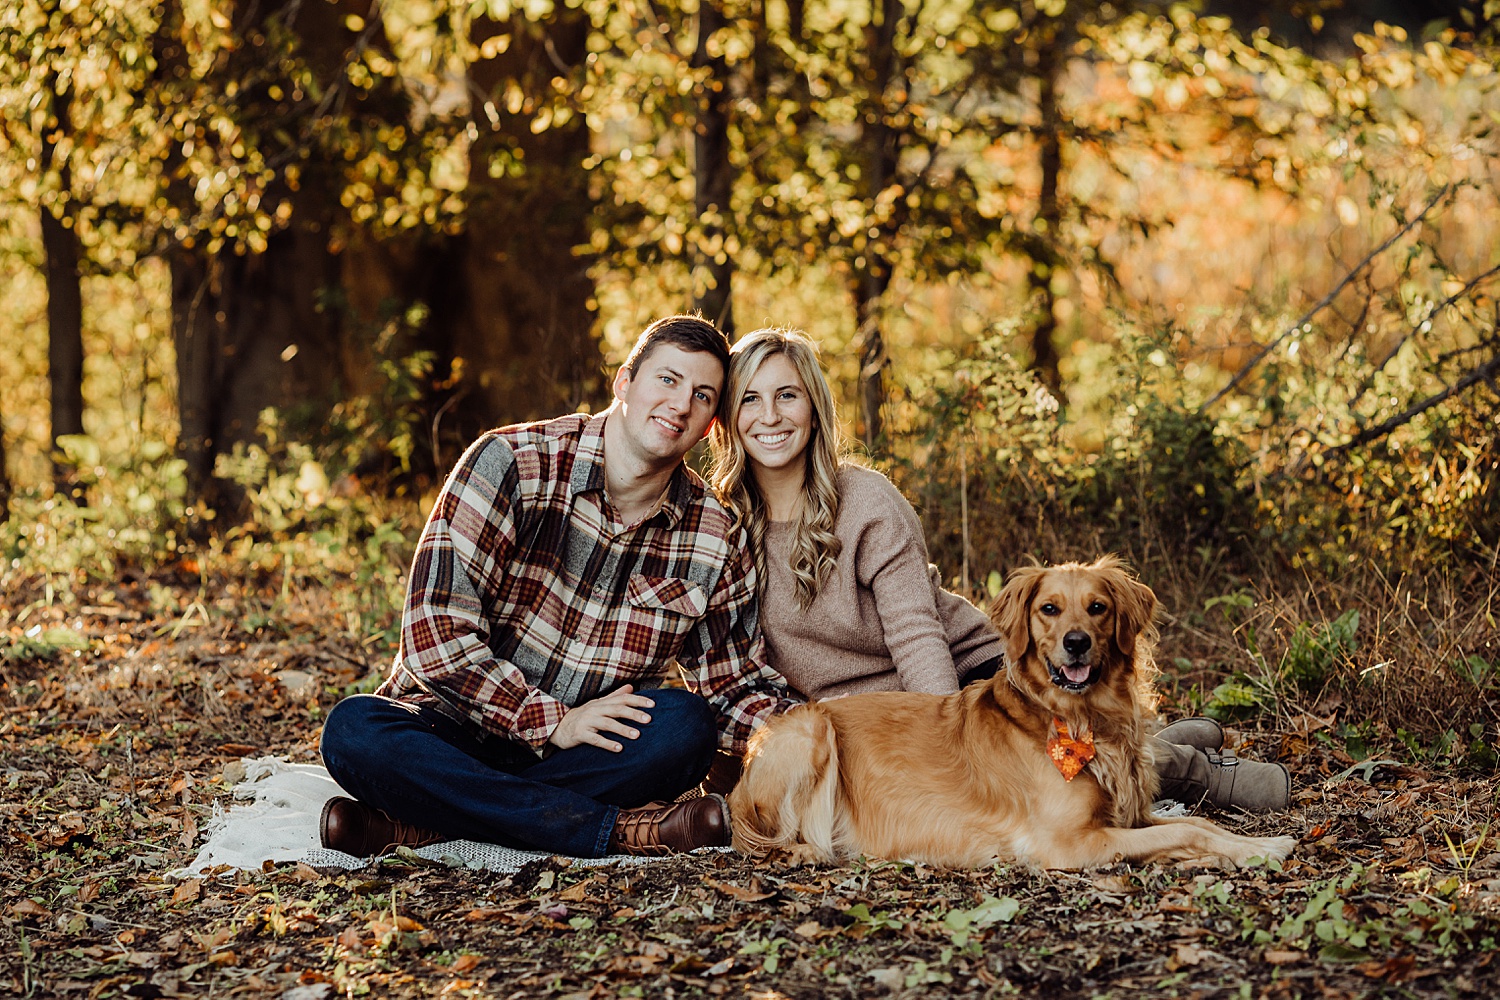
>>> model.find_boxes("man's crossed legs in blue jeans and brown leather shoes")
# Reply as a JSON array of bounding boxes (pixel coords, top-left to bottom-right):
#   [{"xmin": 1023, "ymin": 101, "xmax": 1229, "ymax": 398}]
[{"xmin": 320, "ymin": 688, "xmax": 729, "ymax": 858}]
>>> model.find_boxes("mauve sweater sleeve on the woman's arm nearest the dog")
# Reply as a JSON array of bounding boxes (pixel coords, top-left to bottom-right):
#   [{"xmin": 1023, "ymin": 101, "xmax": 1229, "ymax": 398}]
[{"xmin": 843, "ymin": 472, "xmax": 959, "ymax": 694}]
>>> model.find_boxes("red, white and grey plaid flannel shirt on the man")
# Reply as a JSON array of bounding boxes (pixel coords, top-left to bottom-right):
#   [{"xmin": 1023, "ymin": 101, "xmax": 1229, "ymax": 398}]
[{"xmin": 378, "ymin": 411, "xmax": 791, "ymax": 753}]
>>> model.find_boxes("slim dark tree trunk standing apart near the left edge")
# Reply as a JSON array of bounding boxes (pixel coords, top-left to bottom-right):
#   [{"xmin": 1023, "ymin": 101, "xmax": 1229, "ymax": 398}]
[{"xmin": 42, "ymin": 78, "xmax": 84, "ymax": 496}]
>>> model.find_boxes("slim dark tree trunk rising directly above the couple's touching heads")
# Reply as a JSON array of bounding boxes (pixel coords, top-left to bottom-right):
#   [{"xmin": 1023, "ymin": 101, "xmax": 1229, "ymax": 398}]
[{"xmin": 693, "ymin": 0, "xmax": 735, "ymax": 339}]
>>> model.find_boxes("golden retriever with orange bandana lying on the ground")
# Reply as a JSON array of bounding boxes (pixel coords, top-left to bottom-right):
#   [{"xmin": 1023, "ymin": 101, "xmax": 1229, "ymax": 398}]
[{"xmin": 729, "ymin": 556, "xmax": 1296, "ymax": 868}]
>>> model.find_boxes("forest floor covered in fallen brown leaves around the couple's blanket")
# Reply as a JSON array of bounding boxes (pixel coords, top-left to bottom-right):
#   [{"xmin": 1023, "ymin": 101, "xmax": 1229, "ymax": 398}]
[{"xmin": 0, "ymin": 580, "xmax": 1500, "ymax": 1000}]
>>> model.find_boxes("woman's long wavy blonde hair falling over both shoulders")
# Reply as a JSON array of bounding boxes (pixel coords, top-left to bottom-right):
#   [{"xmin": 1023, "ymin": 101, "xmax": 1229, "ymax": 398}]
[{"xmin": 708, "ymin": 328, "xmax": 845, "ymax": 610}]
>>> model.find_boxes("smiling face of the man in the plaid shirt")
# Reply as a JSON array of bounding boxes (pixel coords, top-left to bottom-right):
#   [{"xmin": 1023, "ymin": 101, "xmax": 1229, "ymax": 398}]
[{"xmin": 615, "ymin": 343, "xmax": 725, "ymax": 462}]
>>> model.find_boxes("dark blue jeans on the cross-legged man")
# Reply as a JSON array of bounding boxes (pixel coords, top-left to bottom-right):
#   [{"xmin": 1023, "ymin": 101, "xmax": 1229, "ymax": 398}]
[{"xmin": 323, "ymin": 688, "xmax": 719, "ymax": 858}]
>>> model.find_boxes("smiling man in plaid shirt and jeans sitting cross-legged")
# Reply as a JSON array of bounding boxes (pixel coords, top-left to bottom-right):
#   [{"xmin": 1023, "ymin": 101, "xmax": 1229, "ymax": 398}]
[{"xmin": 320, "ymin": 316, "xmax": 791, "ymax": 858}]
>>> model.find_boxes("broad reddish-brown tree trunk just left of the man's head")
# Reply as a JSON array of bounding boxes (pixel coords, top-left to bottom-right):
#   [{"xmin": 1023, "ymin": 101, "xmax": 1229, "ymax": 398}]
[{"xmin": 425, "ymin": 4, "xmax": 603, "ymax": 439}]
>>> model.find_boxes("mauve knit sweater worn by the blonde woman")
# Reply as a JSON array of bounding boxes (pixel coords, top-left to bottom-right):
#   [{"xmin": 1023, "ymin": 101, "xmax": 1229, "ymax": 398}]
[{"xmin": 761, "ymin": 465, "xmax": 1002, "ymax": 700}]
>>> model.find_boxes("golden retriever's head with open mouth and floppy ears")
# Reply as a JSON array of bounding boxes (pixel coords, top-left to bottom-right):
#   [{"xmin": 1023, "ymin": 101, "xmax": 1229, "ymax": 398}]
[{"xmin": 990, "ymin": 556, "xmax": 1157, "ymax": 702}]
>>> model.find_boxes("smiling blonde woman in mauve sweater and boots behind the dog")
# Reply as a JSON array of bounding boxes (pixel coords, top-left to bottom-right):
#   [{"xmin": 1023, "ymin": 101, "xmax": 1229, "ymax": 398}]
[{"xmin": 710, "ymin": 328, "xmax": 1292, "ymax": 811}]
